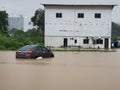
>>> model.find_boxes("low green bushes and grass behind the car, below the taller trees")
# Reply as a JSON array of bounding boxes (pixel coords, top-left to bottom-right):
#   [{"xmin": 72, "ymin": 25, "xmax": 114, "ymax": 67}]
[{"xmin": 0, "ymin": 29, "xmax": 43, "ymax": 50}]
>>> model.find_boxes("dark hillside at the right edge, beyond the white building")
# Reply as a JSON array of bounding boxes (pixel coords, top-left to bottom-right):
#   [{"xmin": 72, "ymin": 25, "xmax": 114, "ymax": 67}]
[{"xmin": 112, "ymin": 22, "xmax": 120, "ymax": 40}]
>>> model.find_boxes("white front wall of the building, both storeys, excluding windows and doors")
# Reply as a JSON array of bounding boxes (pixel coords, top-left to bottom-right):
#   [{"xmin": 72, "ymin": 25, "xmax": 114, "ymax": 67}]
[{"xmin": 45, "ymin": 6, "xmax": 112, "ymax": 48}]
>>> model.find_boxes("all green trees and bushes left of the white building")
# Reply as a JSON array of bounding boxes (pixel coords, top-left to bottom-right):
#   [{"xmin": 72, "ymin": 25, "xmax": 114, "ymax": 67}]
[{"xmin": 0, "ymin": 10, "xmax": 44, "ymax": 50}]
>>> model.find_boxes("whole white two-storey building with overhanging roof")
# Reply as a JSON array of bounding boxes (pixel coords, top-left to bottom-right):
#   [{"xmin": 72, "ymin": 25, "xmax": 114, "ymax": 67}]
[{"xmin": 43, "ymin": 4, "xmax": 115, "ymax": 48}]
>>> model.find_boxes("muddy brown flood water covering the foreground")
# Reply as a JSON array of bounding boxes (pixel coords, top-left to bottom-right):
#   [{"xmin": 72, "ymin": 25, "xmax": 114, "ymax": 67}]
[{"xmin": 0, "ymin": 49, "xmax": 120, "ymax": 90}]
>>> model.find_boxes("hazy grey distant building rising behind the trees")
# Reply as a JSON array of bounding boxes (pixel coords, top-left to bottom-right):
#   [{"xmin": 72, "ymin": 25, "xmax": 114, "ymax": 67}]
[{"xmin": 8, "ymin": 15, "xmax": 24, "ymax": 30}]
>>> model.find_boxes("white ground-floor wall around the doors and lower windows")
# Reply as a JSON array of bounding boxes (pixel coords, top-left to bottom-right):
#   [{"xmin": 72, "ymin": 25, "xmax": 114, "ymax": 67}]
[{"xmin": 45, "ymin": 36, "xmax": 111, "ymax": 48}]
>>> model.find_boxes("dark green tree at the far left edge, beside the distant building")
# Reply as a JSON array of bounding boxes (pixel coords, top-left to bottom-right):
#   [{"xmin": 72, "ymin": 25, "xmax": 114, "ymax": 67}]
[{"xmin": 0, "ymin": 11, "xmax": 8, "ymax": 35}]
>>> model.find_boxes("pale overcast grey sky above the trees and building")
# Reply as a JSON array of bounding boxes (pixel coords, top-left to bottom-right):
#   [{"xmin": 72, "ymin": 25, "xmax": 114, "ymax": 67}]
[{"xmin": 0, "ymin": 0, "xmax": 120, "ymax": 30}]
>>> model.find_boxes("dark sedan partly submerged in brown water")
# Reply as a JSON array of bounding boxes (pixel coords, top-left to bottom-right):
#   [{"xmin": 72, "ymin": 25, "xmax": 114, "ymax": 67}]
[{"xmin": 16, "ymin": 45, "xmax": 54, "ymax": 58}]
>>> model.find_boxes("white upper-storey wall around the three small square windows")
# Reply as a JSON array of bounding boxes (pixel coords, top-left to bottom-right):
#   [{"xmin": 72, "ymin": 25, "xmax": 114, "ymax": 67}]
[{"xmin": 45, "ymin": 6, "xmax": 111, "ymax": 36}]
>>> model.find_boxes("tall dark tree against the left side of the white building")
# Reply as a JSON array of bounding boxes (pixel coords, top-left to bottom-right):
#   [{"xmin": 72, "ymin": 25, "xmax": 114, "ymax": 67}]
[{"xmin": 31, "ymin": 9, "xmax": 45, "ymax": 31}]
